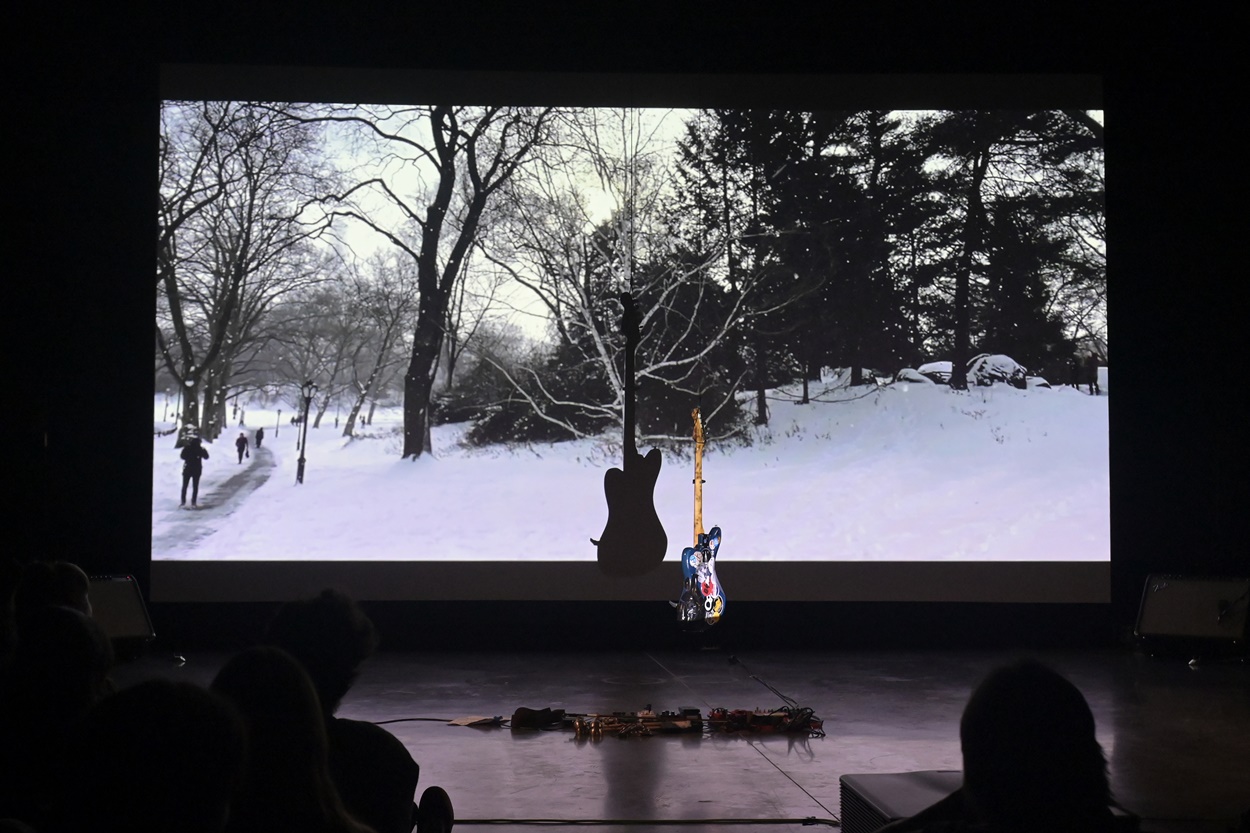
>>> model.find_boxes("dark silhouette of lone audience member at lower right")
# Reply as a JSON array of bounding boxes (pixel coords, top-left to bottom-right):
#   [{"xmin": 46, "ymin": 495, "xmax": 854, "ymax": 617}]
[{"xmin": 883, "ymin": 659, "xmax": 1135, "ymax": 833}]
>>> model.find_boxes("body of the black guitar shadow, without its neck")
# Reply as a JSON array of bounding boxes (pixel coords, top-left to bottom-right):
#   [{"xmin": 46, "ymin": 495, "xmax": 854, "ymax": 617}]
[{"xmin": 594, "ymin": 448, "xmax": 669, "ymax": 575}]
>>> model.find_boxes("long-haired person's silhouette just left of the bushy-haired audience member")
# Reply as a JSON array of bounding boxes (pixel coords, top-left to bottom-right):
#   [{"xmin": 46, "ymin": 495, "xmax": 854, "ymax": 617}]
[{"xmin": 210, "ymin": 647, "xmax": 371, "ymax": 833}]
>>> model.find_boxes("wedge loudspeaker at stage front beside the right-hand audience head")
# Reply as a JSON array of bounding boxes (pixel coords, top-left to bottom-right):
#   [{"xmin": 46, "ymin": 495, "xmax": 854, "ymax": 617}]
[{"xmin": 838, "ymin": 769, "xmax": 964, "ymax": 833}]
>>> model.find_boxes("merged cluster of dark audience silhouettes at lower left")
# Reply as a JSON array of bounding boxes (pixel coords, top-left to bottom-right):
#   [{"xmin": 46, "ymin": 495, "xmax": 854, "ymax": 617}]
[{"xmin": 0, "ymin": 575, "xmax": 454, "ymax": 833}]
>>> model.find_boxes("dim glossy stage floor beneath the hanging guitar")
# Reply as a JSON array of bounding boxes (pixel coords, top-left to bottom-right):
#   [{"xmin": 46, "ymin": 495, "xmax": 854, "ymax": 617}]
[{"xmin": 114, "ymin": 639, "xmax": 1250, "ymax": 833}]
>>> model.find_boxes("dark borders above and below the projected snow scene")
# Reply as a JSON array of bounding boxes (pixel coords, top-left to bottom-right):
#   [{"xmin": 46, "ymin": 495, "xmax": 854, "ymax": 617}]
[{"xmin": 150, "ymin": 64, "xmax": 1116, "ymax": 604}]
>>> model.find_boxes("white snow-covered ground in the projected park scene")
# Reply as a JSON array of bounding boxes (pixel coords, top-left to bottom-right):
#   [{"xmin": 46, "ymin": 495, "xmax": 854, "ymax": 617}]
[{"xmin": 153, "ymin": 383, "xmax": 1111, "ymax": 562}]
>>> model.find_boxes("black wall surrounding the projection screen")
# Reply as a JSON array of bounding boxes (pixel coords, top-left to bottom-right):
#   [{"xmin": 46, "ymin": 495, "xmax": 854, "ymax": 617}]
[{"xmin": 14, "ymin": 3, "xmax": 1248, "ymax": 643}]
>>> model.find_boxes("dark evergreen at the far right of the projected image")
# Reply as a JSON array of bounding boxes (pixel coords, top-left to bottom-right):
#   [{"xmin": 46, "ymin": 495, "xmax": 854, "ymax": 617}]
[{"xmin": 923, "ymin": 110, "xmax": 1105, "ymax": 389}]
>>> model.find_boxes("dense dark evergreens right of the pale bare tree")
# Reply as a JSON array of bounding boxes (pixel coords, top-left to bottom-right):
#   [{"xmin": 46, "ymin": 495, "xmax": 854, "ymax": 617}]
[{"xmin": 683, "ymin": 110, "xmax": 933, "ymax": 400}]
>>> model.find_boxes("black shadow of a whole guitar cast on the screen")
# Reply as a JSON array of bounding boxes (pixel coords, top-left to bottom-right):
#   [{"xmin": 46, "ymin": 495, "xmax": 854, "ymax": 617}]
[{"xmin": 590, "ymin": 293, "xmax": 669, "ymax": 575}]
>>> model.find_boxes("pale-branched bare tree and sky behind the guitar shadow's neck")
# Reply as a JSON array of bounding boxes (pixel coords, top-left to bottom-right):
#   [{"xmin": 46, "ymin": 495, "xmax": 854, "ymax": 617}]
[{"xmin": 485, "ymin": 109, "xmax": 785, "ymax": 437}]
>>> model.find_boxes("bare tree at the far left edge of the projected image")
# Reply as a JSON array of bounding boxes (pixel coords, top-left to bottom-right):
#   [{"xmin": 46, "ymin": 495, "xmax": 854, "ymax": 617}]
[{"xmin": 156, "ymin": 103, "xmax": 324, "ymax": 439}]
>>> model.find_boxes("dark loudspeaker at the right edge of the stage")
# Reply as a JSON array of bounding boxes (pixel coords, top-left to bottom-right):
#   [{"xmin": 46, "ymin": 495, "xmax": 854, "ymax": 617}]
[{"xmin": 1134, "ymin": 574, "xmax": 1250, "ymax": 647}]
